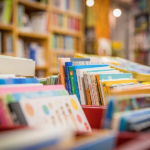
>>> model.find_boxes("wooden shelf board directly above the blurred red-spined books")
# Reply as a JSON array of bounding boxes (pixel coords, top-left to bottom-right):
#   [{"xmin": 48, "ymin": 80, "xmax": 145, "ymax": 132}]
[{"xmin": 50, "ymin": 7, "xmax": 83, "ymax": 19}]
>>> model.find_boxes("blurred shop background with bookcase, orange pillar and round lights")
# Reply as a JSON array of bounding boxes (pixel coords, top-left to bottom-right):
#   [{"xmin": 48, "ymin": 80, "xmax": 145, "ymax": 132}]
[{"xmin": 0, "ymin": 0, "xmax": 150, "ymax": 77}]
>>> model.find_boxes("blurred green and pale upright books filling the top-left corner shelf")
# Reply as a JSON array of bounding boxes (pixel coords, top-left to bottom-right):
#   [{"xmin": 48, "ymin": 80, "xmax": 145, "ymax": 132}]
[{"xmin": 0, "ymin": 0, "xmax": 12, "ymax": 24}]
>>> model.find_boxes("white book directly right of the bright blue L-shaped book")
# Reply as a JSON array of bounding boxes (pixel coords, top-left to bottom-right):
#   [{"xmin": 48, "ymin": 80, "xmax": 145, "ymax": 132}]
[{"xmin": 76, "ymin": 66, "xmax": 110, "ymax": 105}]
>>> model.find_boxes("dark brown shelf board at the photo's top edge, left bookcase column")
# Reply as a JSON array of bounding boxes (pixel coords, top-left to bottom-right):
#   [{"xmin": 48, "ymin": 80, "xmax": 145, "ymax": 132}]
[{"xmin": 18, "ymin": 0, "xmax": 47, "ymax": 11}]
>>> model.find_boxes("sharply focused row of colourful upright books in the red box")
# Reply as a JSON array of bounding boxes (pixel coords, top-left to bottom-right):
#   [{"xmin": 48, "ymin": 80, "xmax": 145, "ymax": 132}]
[{"xmin": 59, "ymin": 58, "xmax": 146, "ymax": 106}]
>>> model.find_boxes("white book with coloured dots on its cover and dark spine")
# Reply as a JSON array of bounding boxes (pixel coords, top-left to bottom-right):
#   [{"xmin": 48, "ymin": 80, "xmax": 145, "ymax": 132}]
[{"xmin": 8, "ymin": 95, "xmax": 91, "ymax": 132}]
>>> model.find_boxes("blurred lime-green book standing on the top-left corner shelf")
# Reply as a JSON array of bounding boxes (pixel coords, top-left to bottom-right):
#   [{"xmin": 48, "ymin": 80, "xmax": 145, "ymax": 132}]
[{"xmin": 2, "ymin": 0, "xmax": 12, "ymax": 24}]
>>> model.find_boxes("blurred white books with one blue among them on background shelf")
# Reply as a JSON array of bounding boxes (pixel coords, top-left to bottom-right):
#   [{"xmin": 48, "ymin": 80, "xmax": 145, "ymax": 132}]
[{"xmin": 17, "ymin": 38, "xmax": 46, "ymax": 66}]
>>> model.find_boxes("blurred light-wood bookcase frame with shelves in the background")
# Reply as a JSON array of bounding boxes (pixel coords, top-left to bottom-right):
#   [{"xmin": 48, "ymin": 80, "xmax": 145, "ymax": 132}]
[{"xmin": 0, "ymin": 0, "xmax": 85, "ymax": 77}]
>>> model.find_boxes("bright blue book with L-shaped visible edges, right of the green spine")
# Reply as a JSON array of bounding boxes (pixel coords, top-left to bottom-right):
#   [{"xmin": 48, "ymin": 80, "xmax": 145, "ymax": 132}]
[{"xmin": 72, "ymin": 65, "xmax": 108, "ymax": 103}]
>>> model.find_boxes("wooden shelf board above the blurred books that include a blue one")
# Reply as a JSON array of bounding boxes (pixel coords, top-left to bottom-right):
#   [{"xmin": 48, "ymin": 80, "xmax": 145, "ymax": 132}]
[{"xmin": 18, "ymin": 30, "xmax": 48, "ymax": 39}]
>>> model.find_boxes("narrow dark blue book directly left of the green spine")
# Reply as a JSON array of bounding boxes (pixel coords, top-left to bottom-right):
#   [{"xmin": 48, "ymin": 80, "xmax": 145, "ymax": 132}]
[{"xmin": 65, "ymin": 62, "xmax": 72, "ymax": 95}]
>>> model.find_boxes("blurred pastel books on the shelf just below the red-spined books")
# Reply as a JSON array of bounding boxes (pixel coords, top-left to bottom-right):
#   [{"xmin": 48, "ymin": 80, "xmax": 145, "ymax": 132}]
[{"xmin": 52, "ymin": 34, "xmax": 78, "ymax": 51}]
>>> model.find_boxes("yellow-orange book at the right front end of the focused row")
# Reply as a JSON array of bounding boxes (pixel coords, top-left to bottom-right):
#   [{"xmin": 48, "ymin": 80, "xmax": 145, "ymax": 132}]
[{"xmin": 100, "ymin": 79, "xmax": 137, "ymax": 104}]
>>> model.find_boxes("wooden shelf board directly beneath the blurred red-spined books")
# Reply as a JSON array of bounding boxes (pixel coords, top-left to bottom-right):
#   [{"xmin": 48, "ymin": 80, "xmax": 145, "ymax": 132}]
[{"xmin": 50, "ymin": 28, "xmax": 82, "ymax": 38}]
